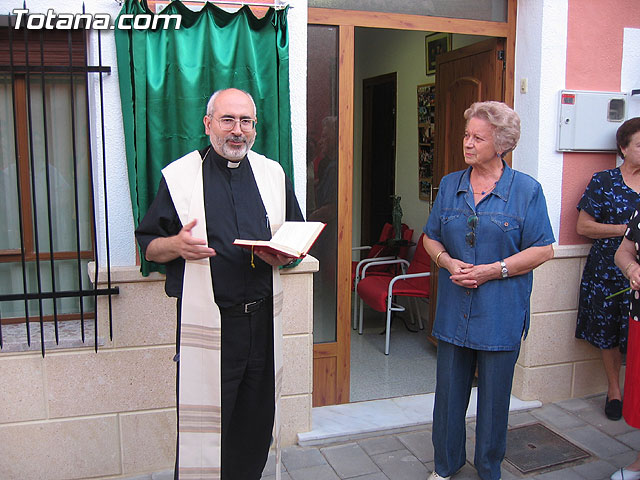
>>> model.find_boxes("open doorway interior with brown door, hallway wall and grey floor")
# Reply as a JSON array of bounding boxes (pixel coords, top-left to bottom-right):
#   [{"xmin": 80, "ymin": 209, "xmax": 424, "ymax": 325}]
[{"xmin": 350, "ymin": 28, "xmax": 503, "ymax": 402}]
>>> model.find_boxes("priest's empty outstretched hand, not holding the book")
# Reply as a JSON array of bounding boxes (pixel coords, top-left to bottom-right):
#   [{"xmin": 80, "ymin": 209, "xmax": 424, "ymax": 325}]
[{"xmin": 146, "ymin": 218, "xmax": 216, "ymax": 263}]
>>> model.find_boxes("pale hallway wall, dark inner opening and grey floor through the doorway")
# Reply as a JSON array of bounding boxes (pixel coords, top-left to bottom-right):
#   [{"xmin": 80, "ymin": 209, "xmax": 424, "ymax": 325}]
[{"xmin": 350, "ymin": 27, "xmax": 444, "ymax": 402}]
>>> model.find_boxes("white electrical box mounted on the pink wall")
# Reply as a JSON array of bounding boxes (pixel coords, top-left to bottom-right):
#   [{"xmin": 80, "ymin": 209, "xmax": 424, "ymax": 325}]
[{"xmin": 557, "ymin": 90, "xmax": 627, "ymax": 152}]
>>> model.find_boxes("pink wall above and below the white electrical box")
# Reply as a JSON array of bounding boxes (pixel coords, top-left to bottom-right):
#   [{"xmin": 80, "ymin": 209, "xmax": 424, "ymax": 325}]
[{"xmin": 559, "ymin": 0, "xmax": 640, "ymax": 245}]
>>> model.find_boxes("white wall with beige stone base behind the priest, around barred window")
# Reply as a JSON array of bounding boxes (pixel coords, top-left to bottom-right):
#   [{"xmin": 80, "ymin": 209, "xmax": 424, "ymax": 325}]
[{"xmin": 0, "ymin": 0, "xmax": 310, "ymax": 480}]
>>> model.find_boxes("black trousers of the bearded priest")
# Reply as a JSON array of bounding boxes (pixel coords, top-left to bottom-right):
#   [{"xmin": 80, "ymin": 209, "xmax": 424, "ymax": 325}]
[{"xmin": 174, "ymin": 299, "xmax": 275, "ymax": 480}]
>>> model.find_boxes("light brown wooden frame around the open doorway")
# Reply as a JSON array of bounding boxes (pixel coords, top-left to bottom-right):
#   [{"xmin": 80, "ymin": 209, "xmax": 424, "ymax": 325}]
[{"xmin": 307, "ymin": 0, "xmax": 517, "ymax": 406}]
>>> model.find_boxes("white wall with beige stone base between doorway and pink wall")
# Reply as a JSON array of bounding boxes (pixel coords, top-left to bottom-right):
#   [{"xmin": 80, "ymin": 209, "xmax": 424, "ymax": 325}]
[{"xmin": 513, "ymin": 0, "xmax": 640, "ymax": 402}]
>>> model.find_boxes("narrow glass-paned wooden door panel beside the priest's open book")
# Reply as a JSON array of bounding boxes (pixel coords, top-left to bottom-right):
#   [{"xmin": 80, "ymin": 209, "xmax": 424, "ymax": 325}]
[{"xmin": 307, "ymin": 25, "xmax": 354, "ymax": 407}]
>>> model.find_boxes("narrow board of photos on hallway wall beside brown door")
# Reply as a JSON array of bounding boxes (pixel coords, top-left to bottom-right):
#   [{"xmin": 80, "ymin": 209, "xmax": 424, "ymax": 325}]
[{"xmin": 417, "ymin": 83, "xmax": 436, "ymax": 201}]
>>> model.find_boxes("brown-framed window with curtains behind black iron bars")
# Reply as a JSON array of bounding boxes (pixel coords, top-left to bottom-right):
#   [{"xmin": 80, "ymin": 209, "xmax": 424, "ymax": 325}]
[{"xmin": 0, "ymin": 21, "xmax": 116, "ymax": 354}]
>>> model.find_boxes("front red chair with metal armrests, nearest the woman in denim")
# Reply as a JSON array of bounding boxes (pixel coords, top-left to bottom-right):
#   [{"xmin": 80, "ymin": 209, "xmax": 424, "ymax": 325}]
[{"xmin": 357, "ymin": 234, "xmax": 431, "ymax": 355}]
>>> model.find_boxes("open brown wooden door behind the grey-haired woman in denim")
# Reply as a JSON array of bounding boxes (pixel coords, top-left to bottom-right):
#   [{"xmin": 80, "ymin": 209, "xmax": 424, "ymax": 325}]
[{"xmin": 428, "ymin": 38, "xmax": 506, "ymax": 338}]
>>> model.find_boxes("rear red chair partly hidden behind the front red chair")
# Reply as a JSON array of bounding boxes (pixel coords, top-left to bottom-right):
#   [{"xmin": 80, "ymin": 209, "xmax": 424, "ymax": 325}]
[{"xmin": 351, "ymin": 223, "xmax": 413, "ymax": 330}]
